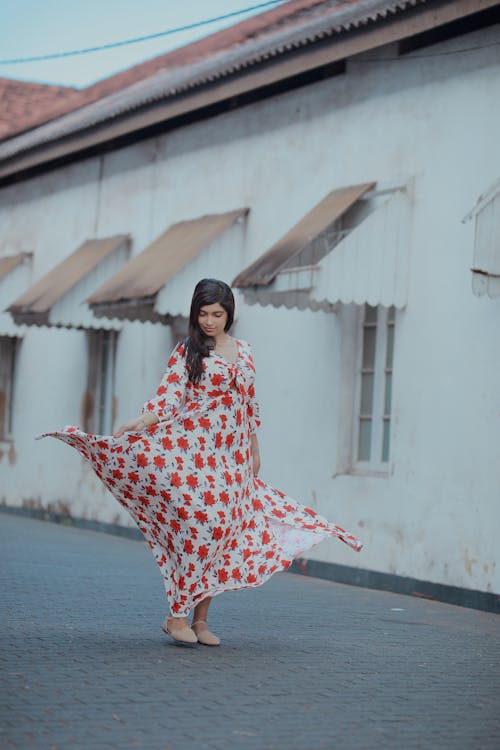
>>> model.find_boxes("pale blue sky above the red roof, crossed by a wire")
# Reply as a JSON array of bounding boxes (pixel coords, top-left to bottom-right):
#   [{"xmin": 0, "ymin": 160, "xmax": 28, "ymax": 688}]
[{"xmin": 0, "ymin": 0, "xmax": 283, "ymax": 88}]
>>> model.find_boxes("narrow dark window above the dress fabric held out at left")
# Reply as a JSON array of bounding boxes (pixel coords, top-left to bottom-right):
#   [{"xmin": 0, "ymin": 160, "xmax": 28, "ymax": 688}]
[{"xmin": 84, "ymin": 330, "xmax": 118, "ymax": 435}]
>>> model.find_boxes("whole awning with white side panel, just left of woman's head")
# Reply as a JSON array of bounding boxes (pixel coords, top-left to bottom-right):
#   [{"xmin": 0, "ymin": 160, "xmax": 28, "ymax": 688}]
[{"xmin": 87, "ymin": 208, "xmax": 249, "ymax": 324}]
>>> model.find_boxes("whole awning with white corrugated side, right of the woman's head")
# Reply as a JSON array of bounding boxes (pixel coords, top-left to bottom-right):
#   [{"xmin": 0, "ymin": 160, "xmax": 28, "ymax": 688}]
[{"xmin": 234, "ymin": 183, "xmax": 410, "ymax": 311}]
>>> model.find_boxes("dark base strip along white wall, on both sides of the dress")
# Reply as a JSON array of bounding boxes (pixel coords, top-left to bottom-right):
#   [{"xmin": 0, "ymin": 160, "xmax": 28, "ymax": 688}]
[{"xmin": 0, "ymin": 505, "xmax": 500, "ymax": 614}]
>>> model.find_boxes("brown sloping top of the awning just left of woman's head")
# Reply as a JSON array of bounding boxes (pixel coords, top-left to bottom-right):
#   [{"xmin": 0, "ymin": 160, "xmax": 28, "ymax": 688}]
[{"xmin": 87, "ymin": 208, "xmax": 249, "ymax": 306}]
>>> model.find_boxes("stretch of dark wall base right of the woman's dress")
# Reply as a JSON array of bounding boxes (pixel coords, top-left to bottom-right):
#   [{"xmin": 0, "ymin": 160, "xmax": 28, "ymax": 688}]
[{"xmin": 288, "ymin": 558, "xmax": 500, "ymax": 614}]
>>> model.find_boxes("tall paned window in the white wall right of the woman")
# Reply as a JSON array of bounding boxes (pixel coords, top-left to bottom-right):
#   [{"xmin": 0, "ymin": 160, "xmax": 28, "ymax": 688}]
[{"xmin": 353, "ymin": 305, "xmax": 395, "ymax": 470}]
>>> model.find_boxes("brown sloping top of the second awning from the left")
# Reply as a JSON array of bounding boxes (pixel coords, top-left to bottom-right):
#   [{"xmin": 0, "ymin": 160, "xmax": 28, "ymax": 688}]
[{"xmin": 7, "ymin": 234, "xmax": 130, "ymax": 325}]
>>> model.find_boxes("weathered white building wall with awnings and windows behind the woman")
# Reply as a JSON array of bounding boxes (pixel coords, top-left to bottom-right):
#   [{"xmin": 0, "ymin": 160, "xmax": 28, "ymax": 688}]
[{"xmin": 0, "ymin": 4, "xmax": 500, "ymax": 608}]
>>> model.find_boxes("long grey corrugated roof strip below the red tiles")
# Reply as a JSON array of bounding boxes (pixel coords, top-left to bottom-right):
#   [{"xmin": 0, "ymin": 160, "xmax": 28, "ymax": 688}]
[{"xmin": 0, "ymin": 0, "xmax": 428, "ymax": 161}]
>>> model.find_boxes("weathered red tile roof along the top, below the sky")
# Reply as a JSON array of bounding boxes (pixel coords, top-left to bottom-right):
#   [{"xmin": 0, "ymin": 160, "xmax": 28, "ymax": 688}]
[{"xmin": 0, "ymin": 0, "xmax": 328, "ymax": 141}]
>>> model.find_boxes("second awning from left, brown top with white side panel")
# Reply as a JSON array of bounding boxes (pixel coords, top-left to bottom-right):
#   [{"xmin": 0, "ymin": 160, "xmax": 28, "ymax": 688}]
[{"xmin": 7, "ymin": 234, "xmax": 130, "ymax": 328}]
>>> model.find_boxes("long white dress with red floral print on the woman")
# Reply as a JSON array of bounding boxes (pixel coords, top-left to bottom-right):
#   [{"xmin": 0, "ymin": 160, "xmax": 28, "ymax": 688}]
[{"xmin": 41, "ymin": 340, "xmax": 362, "ymax": 616}]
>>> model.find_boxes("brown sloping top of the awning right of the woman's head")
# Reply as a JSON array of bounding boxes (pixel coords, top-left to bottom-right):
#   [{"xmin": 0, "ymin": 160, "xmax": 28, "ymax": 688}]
[{"xmin": 233, "ymin": 182, "xmax": 375, "ymax": 289}]
